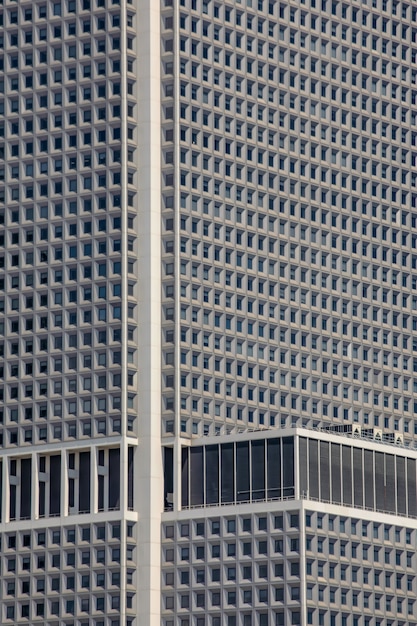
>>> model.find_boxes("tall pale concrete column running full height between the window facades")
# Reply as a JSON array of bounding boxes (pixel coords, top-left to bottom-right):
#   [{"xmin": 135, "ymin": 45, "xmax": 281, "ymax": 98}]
[{"xmin": 134, "ymin": 0, "xmax": 163, "ymax": 626}]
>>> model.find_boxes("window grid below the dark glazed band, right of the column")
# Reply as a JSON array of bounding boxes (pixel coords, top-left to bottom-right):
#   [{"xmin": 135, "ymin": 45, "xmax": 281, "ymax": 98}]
[{"xmin": 162, "ymin": 510, "xmax": 416, "ymax": 626}]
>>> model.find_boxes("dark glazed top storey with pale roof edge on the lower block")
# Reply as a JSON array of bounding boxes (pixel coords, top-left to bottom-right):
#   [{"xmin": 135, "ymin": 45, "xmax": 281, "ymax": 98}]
[{"xmin": 164, "ymin": 428, "xmax": 417, "ymax": 518}]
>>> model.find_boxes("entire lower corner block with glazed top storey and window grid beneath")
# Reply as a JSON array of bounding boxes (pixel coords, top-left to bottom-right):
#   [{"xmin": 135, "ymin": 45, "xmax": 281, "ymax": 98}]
[{"xmin": 161, "ymin": 429, "xmax": 417, "ymax": 626}]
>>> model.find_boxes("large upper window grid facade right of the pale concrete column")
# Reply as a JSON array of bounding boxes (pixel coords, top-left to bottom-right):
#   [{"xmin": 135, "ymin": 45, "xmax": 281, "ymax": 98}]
[{"xmin": 163, "ymin": 2, "xmax": 417, "ymax": 438}]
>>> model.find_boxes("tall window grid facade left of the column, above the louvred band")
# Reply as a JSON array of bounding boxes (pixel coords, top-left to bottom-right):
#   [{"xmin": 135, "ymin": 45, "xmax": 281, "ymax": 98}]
[{"xmin": 0, "ymin": 1, "xmax": 141, "ymax": 447}]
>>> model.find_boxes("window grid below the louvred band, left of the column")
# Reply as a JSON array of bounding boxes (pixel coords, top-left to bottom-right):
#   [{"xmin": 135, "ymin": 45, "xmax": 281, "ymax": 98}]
[{"xmin": 1, "ymin": 521, "xmax": 135, "ymax": 626}]
